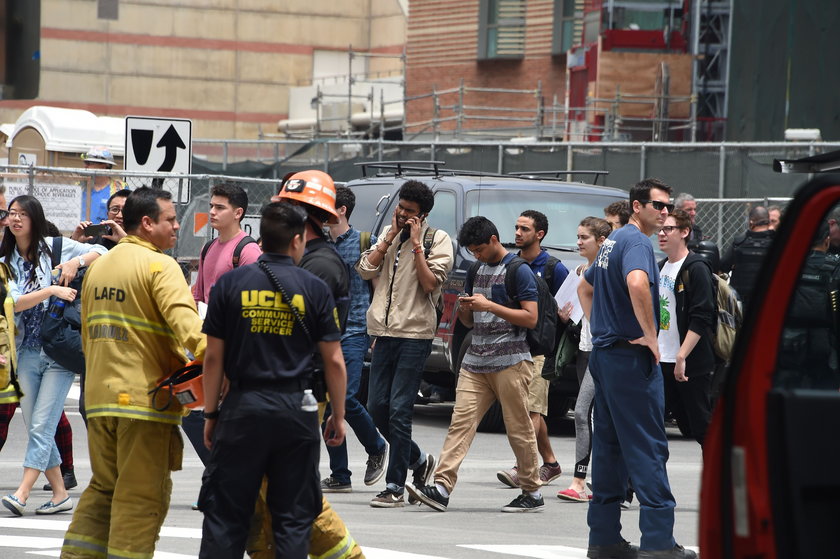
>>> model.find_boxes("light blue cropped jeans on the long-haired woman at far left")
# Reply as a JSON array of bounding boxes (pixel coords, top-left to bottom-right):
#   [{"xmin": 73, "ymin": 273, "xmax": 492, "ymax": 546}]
[{"xmin": 17, "ymin": 347, "xmax": 76, "ymax": 472}]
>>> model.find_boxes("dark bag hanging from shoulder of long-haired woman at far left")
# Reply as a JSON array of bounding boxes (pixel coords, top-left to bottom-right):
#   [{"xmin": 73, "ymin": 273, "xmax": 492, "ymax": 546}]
[{"xmin": 41, "ymin": 237, "xmax": 87, "ymax": 375}]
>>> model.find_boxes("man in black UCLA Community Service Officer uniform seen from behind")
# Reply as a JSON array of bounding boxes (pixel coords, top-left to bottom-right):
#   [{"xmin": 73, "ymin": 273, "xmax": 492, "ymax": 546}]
[{"xmin": 199, "ymin": 203, "xmax": 346, "ymax": 559}]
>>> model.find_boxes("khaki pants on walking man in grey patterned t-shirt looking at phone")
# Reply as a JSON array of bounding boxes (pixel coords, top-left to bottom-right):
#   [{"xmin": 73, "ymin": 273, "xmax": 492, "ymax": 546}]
[{"xmin": 435, "ymin": 361, "xmax": 540, "ymax": 492}]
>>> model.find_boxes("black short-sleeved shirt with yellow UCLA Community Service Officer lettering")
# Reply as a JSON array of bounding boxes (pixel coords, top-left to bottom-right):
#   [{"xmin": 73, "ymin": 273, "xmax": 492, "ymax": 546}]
[{"xmin": 202, "ymin": 254, "xmax": 341, "ymax": 382}]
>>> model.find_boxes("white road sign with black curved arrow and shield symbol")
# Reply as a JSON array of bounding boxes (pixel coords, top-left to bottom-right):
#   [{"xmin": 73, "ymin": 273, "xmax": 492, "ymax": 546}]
[{"xmin": 125, "ymin": 116, "xmax": 192, "ymax": 202}]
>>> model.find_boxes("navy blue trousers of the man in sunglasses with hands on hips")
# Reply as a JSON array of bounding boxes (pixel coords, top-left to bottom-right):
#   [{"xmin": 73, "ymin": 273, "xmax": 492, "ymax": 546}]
[{"xmin": 587, "ymin": 346, "xmax": 676, "ymax": 550}]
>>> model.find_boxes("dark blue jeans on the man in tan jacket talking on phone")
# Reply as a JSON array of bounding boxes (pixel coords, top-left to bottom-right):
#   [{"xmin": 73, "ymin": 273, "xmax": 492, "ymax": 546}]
[{"xmin": 368, "ymin": 337, "xmax": 432, "ymax": 493}]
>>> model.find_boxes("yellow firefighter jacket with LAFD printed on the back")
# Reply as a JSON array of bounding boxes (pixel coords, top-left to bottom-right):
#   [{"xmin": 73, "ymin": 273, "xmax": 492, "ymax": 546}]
[{"xmin": 82, "ymin": 235, "xmax": 207, "ymax": 425}]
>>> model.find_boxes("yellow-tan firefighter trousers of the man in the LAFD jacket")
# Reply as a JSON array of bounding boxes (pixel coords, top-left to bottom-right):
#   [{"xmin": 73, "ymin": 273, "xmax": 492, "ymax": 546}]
[{"xmin": 61, "ymin": 417, "xmax": 184, "ymax": 559}]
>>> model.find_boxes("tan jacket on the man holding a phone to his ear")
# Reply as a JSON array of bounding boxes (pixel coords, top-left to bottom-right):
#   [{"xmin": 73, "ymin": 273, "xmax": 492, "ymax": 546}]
[{"xmin": 356, "ymin": 224, "xmax": 453, "ymax": 339}]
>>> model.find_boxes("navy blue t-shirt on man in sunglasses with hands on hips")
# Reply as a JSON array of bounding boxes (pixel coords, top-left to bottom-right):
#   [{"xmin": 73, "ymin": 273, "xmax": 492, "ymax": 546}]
[{"xmin": 584, "ymin": 225, "xmax": 659, "ymax": 347}]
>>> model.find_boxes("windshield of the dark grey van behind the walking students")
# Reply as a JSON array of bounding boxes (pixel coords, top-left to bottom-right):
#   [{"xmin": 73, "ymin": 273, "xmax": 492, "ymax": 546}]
[{"xmin": 465, "ymin": 189, "xmax": 626, "ymax": 247}]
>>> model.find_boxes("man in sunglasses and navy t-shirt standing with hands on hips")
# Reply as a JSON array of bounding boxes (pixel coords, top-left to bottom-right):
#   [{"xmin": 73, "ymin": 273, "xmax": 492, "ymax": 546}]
[{"xmin": 578, "ymin": 179, "xmax": 697, "ymax": 559}]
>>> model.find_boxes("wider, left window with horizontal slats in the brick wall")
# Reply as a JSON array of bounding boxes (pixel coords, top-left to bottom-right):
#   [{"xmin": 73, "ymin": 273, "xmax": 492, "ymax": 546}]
[{"xmin": 478, "ymin": 0, "xmax": 525, "ymax": 60}]
